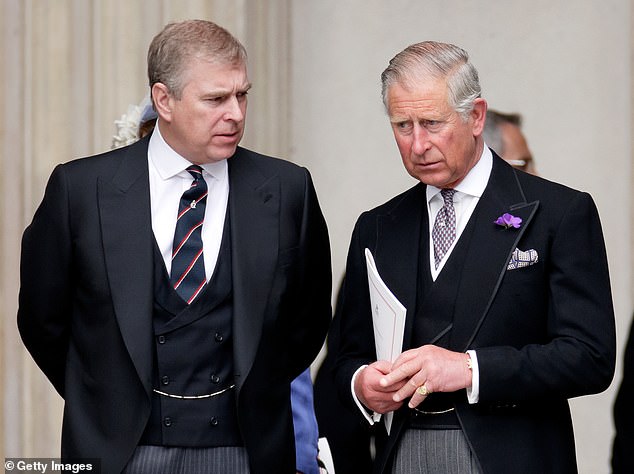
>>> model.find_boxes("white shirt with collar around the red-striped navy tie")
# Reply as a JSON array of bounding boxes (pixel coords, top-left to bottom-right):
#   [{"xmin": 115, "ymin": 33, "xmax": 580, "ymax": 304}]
[{"xmin": 148, "ymin": 124, "xmax": 229, "ymax": 281}]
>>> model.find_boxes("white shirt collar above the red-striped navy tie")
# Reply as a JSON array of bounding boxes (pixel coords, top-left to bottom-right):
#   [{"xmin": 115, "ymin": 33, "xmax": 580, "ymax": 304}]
[{"xmin": 148, "ymin": 121, "xmax": 228, "ymax": 180}]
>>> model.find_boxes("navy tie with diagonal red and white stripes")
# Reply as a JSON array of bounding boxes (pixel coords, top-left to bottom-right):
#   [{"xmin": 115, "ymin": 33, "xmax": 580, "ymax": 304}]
[{"xmin": 170, "ymin": 165, "xmax": 207, "ymax": 304}]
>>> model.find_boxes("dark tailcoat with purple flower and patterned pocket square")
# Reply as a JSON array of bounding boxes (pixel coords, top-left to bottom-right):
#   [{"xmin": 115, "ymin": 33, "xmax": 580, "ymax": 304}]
[{"xmin": 337, "ymin": 156, "xmax": 615, "ymax": 474}]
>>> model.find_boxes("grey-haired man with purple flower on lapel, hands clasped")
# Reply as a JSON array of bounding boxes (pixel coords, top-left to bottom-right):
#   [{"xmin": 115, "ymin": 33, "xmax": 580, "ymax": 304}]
[{"xmin": 337, "ymin": 42, "xmax": 615, "ymax": 474}]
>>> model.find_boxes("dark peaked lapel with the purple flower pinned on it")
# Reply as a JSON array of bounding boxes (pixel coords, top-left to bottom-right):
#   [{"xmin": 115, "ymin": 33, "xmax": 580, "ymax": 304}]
[{"xmin": 451, "ymin": 156, "xmax": 539, "ymax": 350}]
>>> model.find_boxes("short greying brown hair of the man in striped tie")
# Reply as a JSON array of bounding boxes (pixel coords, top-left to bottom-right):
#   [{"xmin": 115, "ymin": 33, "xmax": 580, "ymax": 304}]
[{"xmin": 147, "ymin": 20, "xmax": 247, "ymax": 99}]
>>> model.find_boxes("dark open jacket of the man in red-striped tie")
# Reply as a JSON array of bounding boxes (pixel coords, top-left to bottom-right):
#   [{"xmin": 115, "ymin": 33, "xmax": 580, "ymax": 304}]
[{"xmin": 18, "ymin": 135, "xmax": 331, "ymax": 474}]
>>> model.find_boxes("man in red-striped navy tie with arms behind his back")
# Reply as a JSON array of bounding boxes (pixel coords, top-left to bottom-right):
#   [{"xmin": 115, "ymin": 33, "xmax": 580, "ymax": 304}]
[{"xmin": 18, "ymin": 20, "xmax": 331, "ymax": 474}]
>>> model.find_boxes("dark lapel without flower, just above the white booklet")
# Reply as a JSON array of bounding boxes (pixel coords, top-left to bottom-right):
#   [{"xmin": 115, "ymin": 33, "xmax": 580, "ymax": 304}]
[{"xmin": 370, "ymin": 184, "xmax": 428, "ymax": 349}]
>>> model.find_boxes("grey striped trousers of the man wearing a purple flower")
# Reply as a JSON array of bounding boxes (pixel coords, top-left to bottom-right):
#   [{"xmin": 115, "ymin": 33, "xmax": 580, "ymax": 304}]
[{"xmin": 392, "ymin": 428, "xmax": 482, "ymax": 474}]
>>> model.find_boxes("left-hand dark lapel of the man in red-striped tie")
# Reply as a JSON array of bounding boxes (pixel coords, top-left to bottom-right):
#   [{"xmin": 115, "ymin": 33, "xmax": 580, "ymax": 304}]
[{"xmin": 97, "ymin": 140, "xmax": 153, "ymax": 395}]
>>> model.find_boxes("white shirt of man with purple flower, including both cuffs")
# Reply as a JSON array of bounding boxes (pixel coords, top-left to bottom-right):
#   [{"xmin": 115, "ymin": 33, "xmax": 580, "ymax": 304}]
[{"xmin": 350, "ymin": 144, "xmax": 493, "ymax": 424}]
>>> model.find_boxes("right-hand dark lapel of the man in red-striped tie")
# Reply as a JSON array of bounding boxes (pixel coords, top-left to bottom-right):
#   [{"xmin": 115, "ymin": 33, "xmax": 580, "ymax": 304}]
[{"xmin": 229, "ymin": 148, "xmax": 280, "ymax": 389}]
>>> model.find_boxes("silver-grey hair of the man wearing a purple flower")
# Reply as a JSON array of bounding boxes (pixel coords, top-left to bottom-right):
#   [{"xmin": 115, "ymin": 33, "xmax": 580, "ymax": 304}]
[{"xmin": 381, "ymin": 41, "xmax": 482, "ymax": 120}]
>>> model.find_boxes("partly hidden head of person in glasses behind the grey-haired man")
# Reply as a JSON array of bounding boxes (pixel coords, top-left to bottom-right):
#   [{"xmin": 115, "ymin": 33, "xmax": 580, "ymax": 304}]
[{"xmin": 482, "ymin": 109, "xmax": 537, "ymax": 174}]
